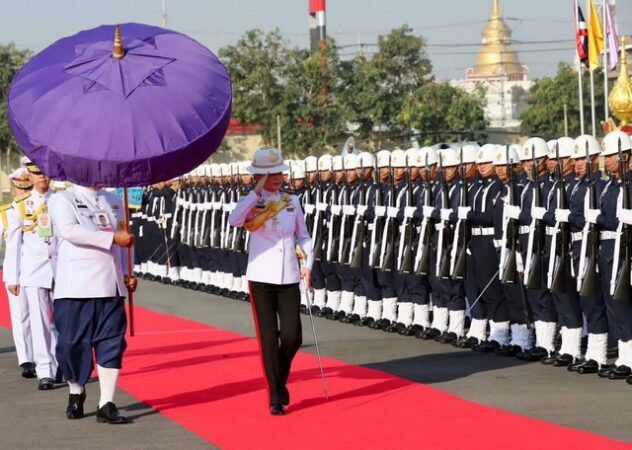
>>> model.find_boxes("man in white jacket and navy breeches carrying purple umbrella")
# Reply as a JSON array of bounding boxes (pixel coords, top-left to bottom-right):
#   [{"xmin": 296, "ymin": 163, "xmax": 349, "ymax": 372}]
[{"xmin": 50, "ymin": 186, "xmax": 136, "ymax": 424}]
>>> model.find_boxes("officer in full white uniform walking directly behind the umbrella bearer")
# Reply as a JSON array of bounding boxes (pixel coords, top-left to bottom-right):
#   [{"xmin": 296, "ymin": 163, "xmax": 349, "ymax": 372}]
[{"xmin": 4, "ymin": 158, "xmax": 61, "ymax": 390}]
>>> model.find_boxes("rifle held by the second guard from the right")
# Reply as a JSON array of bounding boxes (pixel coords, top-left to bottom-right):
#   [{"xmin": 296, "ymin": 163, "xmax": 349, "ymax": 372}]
[{"xmin": 577, "ymin": 141, "xmax": 599, "ymax": 297}]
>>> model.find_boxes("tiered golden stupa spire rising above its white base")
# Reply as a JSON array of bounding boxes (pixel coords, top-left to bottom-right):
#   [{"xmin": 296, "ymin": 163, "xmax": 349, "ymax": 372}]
[{"xmin": 467, "ymin": 0, "xmax": 526, "ymax": 80}]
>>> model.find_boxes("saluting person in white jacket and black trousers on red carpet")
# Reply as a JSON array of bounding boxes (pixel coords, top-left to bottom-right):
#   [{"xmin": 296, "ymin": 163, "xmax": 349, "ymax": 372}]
[{"xmin": 228, "ymin": 148, "xmax": 313, "ymax": 415}]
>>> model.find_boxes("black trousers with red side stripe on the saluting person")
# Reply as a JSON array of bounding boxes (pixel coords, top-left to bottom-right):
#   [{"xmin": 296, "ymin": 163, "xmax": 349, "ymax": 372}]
[{"xmin": 250, "ymin": 281, "xmax": 303, "ymax": 404}]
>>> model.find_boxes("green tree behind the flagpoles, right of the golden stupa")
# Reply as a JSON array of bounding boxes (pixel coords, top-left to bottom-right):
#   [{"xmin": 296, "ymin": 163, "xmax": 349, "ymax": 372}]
[{"xmin": 520, "ymin": 63, "xmax": 604, "ymax": 137}]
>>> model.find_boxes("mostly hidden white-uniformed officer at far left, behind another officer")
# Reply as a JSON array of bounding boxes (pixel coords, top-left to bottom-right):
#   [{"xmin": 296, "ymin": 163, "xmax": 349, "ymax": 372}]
[{"xmin": 0, "ymin": 167, "xmax": 37, "ymax": 378}]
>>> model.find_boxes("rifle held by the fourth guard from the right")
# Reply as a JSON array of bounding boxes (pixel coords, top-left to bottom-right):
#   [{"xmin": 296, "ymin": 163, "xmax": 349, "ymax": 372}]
[{"xmin": 524, "ymin": 144, "xmax": 545, "ymax": 289}]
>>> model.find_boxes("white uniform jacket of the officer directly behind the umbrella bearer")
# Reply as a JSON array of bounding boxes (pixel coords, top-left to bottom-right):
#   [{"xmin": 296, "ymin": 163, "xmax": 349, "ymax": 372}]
[{"xmin": 3, "ymin": 189, "xmax": 57, "ymax": 289}]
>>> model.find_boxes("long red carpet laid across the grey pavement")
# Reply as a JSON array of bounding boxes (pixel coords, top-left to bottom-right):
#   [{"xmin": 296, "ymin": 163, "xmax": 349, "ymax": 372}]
[{"xmin": 0, "ymin": 284, "xmax": 632, "ymax": 450}]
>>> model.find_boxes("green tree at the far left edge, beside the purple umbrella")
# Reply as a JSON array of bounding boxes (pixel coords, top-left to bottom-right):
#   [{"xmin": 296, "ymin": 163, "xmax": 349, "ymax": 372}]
[{"xmin": 0, "ymin": 43, "xmax": 32, "ymax": 165}]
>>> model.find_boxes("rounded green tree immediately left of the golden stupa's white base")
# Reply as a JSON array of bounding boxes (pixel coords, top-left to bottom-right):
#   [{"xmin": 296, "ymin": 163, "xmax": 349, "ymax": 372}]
[{"xmin": 397, "ymin": 82, "xmax": 488, "ymax": 144}]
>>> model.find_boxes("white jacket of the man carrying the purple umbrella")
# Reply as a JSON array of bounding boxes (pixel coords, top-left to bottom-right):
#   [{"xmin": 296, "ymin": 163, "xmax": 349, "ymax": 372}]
[{"xmin": 49, "ymin": 186, "xmax": 127, "ymax": 299}]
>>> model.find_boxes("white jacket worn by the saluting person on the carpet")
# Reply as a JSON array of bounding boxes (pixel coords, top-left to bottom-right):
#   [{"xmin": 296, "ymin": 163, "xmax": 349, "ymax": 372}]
[{"xmin": 228, "ymin": 190, "xmax": 314, "ymax": 284}]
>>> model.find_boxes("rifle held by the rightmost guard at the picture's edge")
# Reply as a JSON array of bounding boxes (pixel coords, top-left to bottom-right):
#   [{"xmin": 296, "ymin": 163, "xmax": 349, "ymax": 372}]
[{"xmin": 610, "ymin": 138, "xmax": 632, "ymax": 301}]
